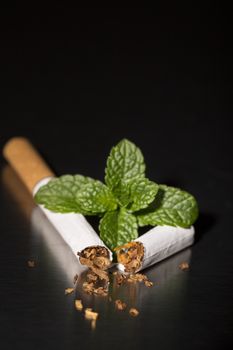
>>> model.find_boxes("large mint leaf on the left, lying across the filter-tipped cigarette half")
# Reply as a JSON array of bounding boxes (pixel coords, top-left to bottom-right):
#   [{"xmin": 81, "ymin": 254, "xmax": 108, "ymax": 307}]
[{"xmin": 34, "ymin": 175, "xmax": 95, "ymax": 215}]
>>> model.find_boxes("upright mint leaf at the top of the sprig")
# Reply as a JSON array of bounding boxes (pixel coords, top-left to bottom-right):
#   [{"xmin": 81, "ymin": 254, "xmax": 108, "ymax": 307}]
[{"xmin": 105, "ymin": 139, "xmax": 145, "ymax": 193}]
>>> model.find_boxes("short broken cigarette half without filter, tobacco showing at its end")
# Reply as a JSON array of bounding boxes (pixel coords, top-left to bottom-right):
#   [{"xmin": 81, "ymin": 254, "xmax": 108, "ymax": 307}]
[{"xmin": 116, "ymin": 226, "xmax": 195, "ymax": 273}]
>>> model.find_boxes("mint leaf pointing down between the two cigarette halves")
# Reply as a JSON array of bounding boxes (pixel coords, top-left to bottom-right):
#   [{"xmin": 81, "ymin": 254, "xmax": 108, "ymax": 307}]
[{"xmin": 99, "ymin": 208, "xmax": 138, "ymax": 249}]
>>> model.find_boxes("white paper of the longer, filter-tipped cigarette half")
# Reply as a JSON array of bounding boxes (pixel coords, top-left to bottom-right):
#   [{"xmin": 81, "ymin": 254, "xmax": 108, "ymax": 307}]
[{"xmin": 33, "ymin": 177, "xmax": 112, "ymax": 260}]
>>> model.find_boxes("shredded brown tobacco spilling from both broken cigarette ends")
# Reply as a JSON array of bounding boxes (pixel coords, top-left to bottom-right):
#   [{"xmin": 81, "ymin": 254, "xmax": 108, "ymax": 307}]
[{"xmin": 75, "ymin": 242, "xmax": 157, "ymax": 322}]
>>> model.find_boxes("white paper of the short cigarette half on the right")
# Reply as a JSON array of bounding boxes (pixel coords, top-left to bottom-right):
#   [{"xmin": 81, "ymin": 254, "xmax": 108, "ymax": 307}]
[{"xmin": 118, "ymin": 226, "xmax": 195, "ymax": 272}]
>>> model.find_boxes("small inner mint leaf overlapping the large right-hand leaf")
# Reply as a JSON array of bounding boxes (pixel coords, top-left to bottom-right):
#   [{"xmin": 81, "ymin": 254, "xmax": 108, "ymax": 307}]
[{"xmin": 130, "ymin": 178, "xmax": 159, "ymax": 212}]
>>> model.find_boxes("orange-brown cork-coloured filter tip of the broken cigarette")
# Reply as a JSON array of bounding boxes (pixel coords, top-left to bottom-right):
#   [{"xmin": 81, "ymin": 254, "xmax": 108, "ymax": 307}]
[{"xmin": 3, "ymin": 137, "xmax": 54, "ymax": 193}]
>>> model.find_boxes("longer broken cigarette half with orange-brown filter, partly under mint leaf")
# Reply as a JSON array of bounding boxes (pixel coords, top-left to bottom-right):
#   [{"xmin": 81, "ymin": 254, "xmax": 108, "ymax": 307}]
[{"xmin": 3, "ymin": 137, "xmax": 112, "ymax": 264}]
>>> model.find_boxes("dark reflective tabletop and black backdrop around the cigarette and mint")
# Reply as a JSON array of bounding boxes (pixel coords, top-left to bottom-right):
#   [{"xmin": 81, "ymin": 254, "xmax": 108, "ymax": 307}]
[{"xmin": 0, "ymin": 3, "xmax": 233, "ymax": 350}]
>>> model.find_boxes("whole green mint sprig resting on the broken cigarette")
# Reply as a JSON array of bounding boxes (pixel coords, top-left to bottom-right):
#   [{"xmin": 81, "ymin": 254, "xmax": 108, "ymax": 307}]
[{"xmin": 35, "ymin": 139, "xmax": 198, "ymax": 249}]
